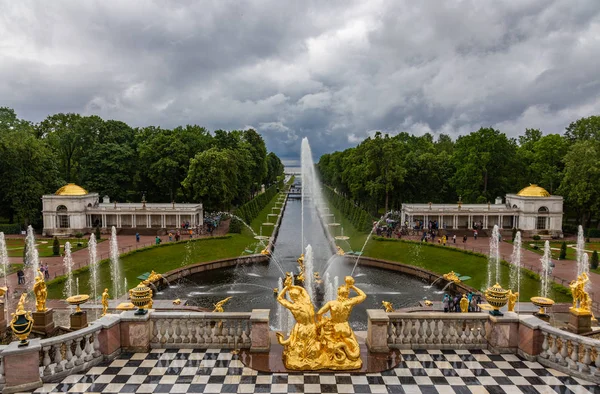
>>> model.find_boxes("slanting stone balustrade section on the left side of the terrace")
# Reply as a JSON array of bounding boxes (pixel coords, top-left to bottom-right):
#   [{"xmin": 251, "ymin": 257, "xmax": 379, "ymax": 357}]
[{"xmin": 40, "ymin": 324, "xmax": 104, "ymax": 382}]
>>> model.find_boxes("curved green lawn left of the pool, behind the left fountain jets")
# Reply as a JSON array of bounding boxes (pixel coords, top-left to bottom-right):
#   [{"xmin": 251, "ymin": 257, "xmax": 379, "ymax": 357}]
[{"xmin": 48, "ymin": 234, "xmax": 256, "ymax": 299}]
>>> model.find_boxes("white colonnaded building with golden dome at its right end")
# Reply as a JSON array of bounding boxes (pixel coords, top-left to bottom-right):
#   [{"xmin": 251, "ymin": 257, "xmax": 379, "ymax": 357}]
[{"xmin": 401, "ymin": 185, "xmax": 563, "ymax": 236}]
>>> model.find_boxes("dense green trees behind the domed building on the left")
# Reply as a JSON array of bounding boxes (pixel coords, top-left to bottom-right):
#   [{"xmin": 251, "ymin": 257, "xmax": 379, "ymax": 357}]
[{"xmin": 0, "ymin": 108, "xmax": 283, "ymax": 225}]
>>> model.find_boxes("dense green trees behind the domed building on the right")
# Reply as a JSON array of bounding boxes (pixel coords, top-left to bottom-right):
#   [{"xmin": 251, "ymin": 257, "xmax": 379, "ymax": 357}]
[{"xmin": 318, "ymin": 116, "xmax": 600, "ymax": 227}]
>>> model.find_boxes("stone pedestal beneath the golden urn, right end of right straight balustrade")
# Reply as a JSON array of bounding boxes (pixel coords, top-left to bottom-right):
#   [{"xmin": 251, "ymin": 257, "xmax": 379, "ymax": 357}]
[{"xmin": 486, "ymin": 312, "xmax": 519, "ymax": 353}]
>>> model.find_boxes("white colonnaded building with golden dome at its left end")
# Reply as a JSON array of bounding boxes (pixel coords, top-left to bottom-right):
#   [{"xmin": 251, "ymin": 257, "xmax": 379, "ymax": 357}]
[{"xmin": 42, "ymin": 183, "xmax": 204, "ymax": 236}]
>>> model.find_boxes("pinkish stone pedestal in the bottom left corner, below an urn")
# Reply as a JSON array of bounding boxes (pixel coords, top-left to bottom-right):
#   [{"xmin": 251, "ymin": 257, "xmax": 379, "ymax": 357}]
[{"xmin": 2, "ymin": 338, "xmax": 42, "ymax": 394}]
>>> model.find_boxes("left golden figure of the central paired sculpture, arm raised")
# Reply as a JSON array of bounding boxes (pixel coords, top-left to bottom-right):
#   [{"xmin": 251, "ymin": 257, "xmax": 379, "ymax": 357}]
[{"xmin": 277, "ymin": 274, "xmax": 324, "ymax": 371}]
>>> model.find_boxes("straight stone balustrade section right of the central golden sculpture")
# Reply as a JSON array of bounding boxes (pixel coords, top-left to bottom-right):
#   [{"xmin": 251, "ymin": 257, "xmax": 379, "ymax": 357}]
[{"xmin": 387, "ymin": 312, "xmax": 488, "ymax": 349}]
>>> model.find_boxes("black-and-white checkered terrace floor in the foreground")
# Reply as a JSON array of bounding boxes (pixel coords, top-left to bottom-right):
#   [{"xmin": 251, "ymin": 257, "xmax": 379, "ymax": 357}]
[{"xmin": 29, "ymin": 349, "xmax": 600, "ymax": 394}]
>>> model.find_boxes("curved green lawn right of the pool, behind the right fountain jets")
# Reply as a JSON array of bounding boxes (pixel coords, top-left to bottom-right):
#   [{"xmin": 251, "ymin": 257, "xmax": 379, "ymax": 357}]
[{"xmin": 364, "ymin": 239, "xmax": 571, "ymax": 302}]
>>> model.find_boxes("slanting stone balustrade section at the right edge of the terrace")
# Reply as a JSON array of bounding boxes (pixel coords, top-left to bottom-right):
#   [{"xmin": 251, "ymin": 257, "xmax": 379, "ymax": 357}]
[{"xmin": 537, "ymin": 325, "xmax": 600, "ymax": 383}]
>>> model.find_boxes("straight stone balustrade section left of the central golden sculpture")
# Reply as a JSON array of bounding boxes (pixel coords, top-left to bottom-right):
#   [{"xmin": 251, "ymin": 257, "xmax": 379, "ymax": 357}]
[{"xmin": 150, "ymin": 312, "xmax": 252, "ymax": 349}]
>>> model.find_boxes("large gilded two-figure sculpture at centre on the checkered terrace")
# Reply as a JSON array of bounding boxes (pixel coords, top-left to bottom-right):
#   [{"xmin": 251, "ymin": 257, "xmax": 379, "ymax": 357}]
[{"xmin": 277, "ymin": 274, "xmax": 367, "ymax": 371}]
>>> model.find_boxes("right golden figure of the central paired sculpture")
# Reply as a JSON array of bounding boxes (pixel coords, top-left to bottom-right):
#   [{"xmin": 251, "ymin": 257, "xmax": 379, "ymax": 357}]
[{"xmin": 317, "ymin": 276, "xmax": 367, "ymax": 370}]
